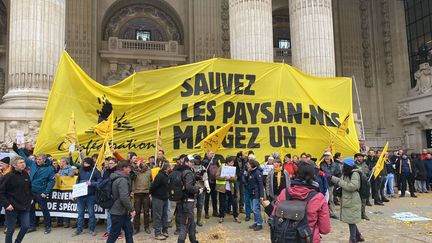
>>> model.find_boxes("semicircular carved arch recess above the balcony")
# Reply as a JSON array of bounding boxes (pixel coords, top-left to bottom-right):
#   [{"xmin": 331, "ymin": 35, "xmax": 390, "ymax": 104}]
[{"xmin": 103, "ymin": 4, "xmax": 183, "ymax": 44}]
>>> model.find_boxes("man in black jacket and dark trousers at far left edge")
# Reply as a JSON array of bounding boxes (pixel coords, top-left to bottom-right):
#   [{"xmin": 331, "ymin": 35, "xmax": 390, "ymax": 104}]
[{"xmin": 0, "ymin": 156, "xmax": 33, "ymax": 243}]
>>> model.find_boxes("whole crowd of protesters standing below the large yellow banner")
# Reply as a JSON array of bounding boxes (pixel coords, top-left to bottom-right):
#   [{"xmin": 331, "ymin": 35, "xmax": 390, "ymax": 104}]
[{"xmin": 0, "ymin": 140, "xmax": 432, "ymax": 243}]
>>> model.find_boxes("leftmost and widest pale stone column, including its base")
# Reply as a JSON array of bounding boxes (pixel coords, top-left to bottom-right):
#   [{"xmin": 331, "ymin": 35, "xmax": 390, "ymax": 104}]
[{"xmin": 0, "ymin": 0, "xmax": 65, "ymax": 118}]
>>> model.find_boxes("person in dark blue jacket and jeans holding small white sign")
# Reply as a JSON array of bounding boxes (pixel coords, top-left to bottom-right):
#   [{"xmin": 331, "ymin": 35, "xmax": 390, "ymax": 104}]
[{"xmin": 73, "ymin": 158, "xmax": 102, "ymax": 236}]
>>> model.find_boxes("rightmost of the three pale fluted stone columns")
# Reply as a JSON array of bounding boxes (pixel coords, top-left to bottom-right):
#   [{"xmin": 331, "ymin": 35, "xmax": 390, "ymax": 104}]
[{"xmin": 289, "ymin": 0, "xmax": 336, "ymax": 77}]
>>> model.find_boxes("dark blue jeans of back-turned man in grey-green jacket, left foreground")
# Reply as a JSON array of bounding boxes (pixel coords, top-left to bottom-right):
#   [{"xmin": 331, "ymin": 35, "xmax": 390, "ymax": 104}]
[{"xmin": 106, "ymin": 215, "xmax": 133, "ymax": 243}]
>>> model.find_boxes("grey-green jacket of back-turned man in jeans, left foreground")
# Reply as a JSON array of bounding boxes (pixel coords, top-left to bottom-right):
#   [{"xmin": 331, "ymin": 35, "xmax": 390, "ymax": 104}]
[{"xmin": 109, "ymin": 171, "xmax": 135, "ymax": 215}]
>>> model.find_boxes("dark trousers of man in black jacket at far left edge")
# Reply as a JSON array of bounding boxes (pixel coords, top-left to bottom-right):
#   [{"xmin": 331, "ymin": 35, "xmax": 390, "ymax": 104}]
[{"xmin": 5, "ymin": 210, "xmax": 30, "ymax": 243}]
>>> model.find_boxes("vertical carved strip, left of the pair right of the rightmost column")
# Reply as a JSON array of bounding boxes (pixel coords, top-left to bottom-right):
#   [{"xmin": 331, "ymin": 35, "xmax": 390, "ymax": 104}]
[{"xmin": 360, "ymin": 0, "xmax": 373, "ymax": 88}]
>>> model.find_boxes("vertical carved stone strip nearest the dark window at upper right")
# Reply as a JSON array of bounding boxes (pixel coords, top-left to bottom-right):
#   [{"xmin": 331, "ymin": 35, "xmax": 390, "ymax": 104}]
[{"xmin": 381, "ymin": 0, "xmax": 394, "ymax": 85}]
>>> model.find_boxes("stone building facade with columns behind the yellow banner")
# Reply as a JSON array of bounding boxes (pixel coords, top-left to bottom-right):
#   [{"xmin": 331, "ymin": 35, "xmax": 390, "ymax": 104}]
[{"xmin": 0, "ymin": 0, "xmax": 426, "ymax": 150}]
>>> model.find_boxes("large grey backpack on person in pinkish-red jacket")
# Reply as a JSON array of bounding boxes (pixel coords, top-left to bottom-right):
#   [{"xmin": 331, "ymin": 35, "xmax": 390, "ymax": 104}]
[{"xmin": 269, "ymin": 190, "xmax": 318, "ymax": 243}]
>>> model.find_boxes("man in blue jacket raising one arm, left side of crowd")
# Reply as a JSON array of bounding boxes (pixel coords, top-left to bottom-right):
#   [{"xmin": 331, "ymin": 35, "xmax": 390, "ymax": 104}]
[{"xmin": 13, "ymin": 143, "xmax": 55, "ymax": 234}]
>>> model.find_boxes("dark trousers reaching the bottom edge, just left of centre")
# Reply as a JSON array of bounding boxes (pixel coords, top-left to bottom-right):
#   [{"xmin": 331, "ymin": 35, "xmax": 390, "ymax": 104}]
[{"xmin": 177, "ymin": 202, "xmax": 196, "ymax": 243}]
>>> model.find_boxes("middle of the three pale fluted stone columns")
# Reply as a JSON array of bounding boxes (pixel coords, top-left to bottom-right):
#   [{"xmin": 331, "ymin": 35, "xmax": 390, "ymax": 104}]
[{"xmin": 229, "ymin": 0, "xmax": 273, "ymax": 62}]
